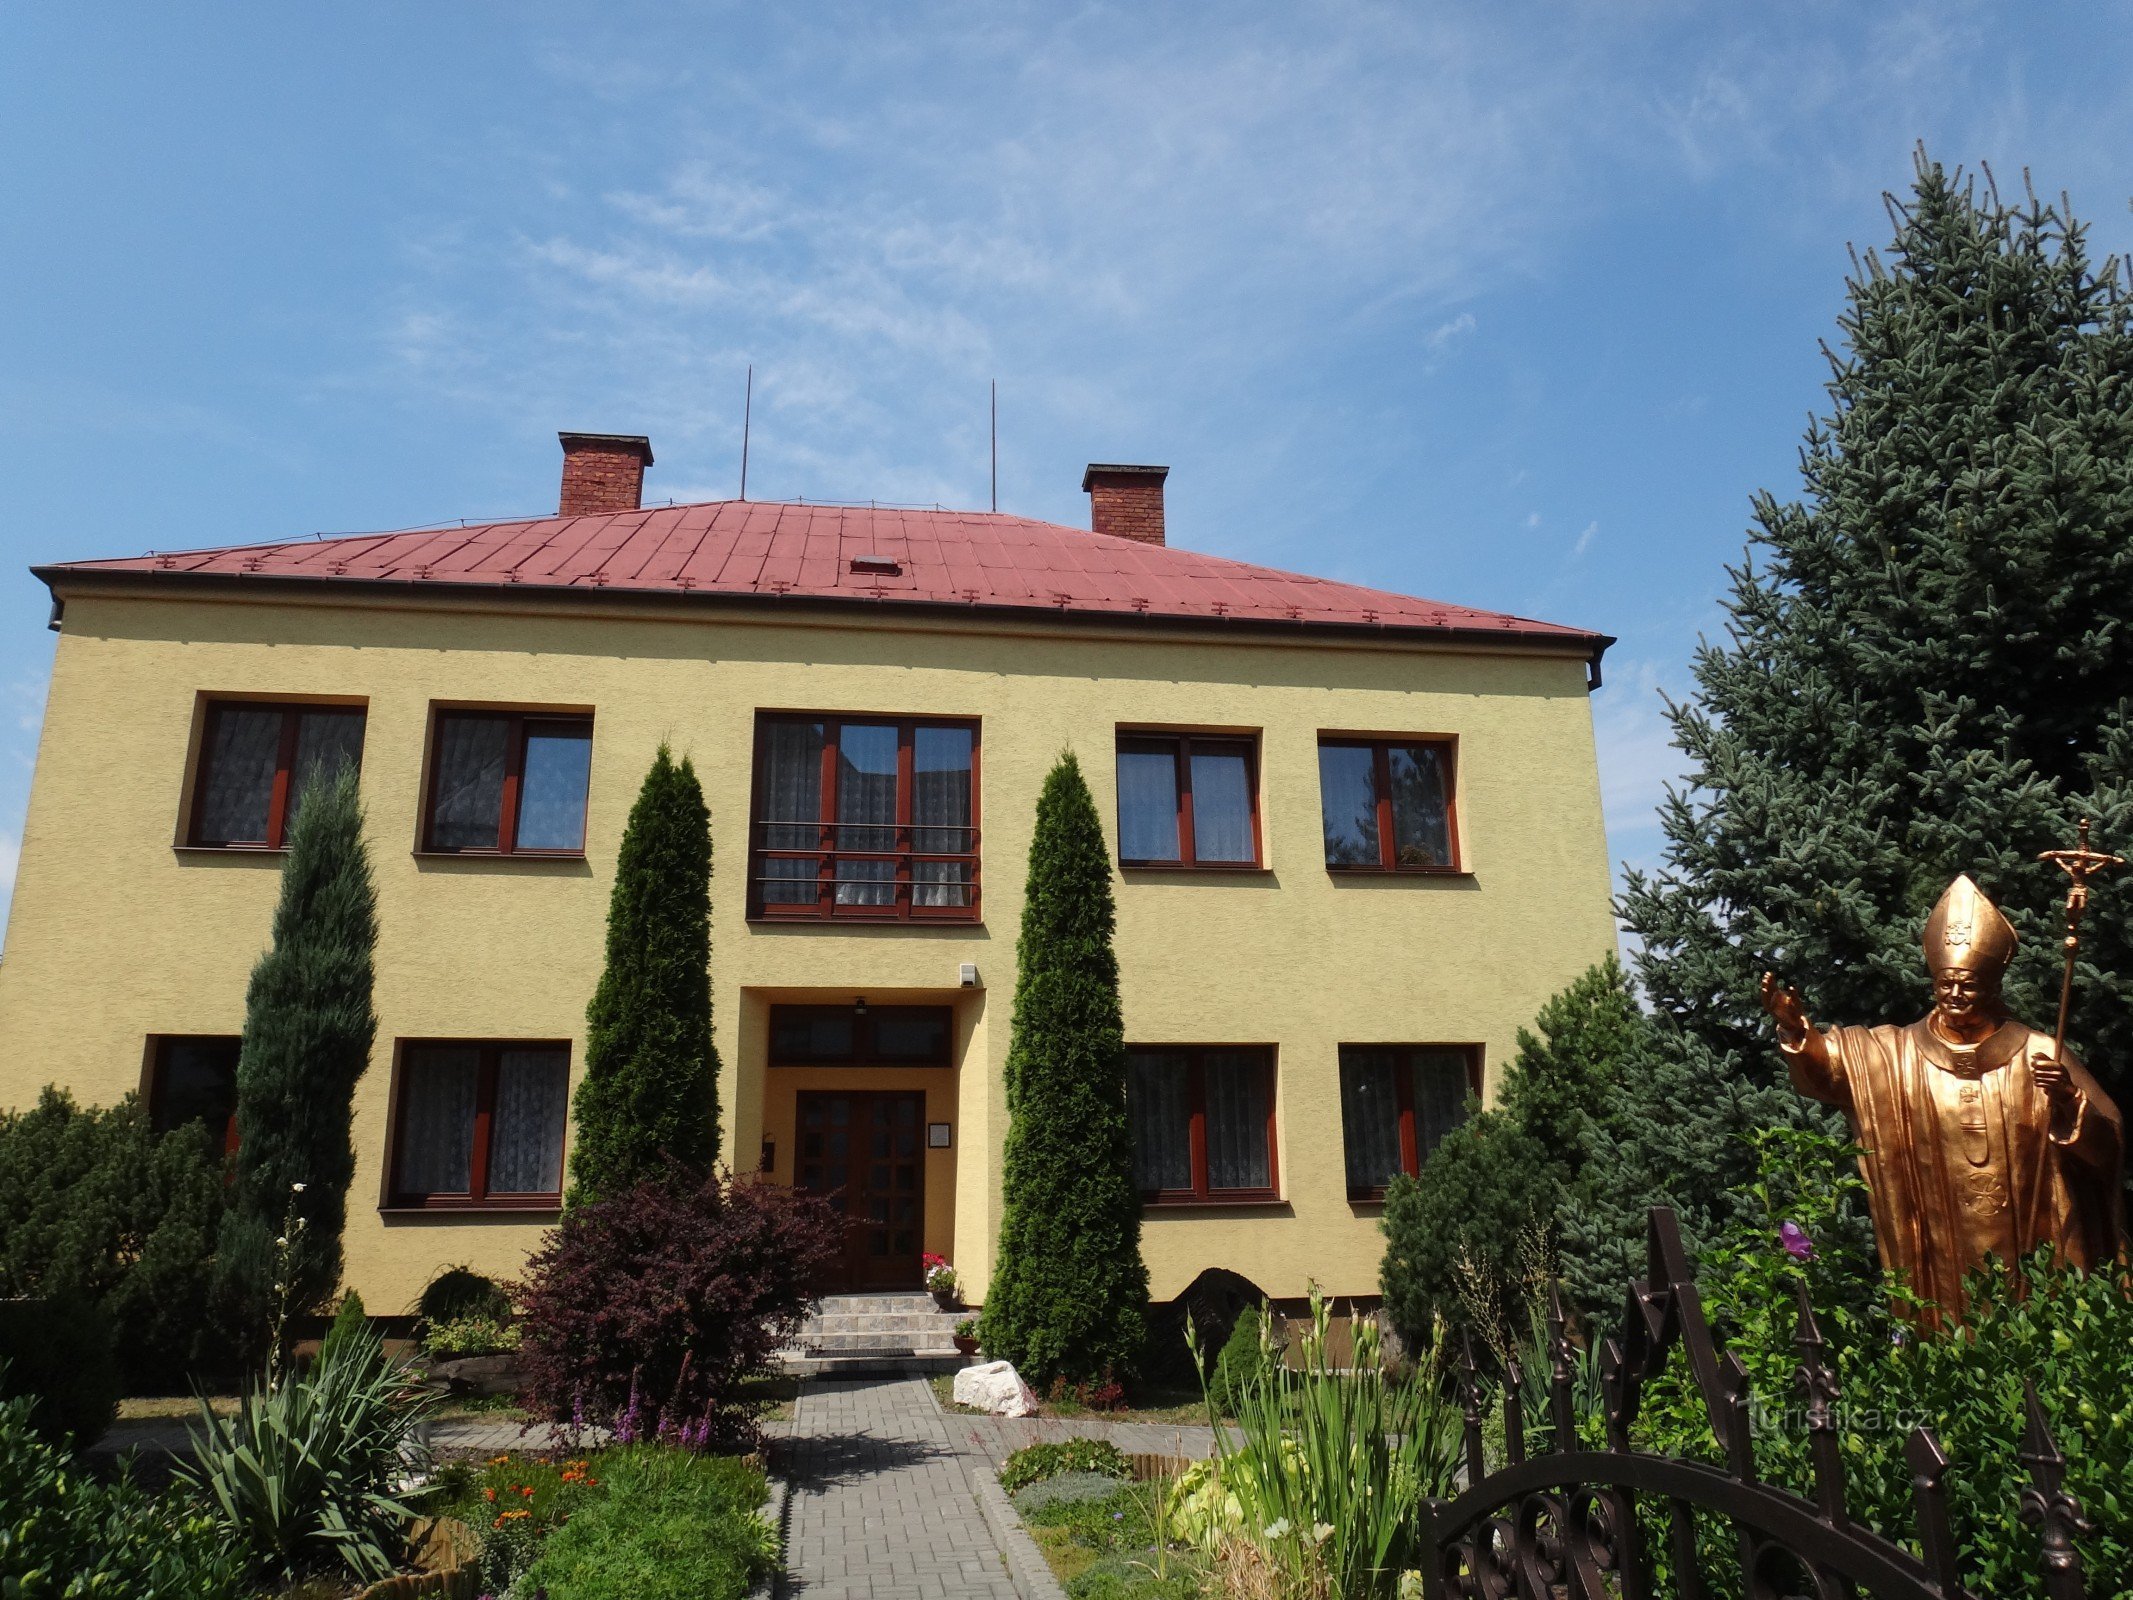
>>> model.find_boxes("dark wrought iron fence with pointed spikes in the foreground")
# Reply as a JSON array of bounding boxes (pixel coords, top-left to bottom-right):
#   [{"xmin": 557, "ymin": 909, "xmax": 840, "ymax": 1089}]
[{"xmin": 1423, "ymin": 1205, "xmax": 2088, "ymax": 1600}]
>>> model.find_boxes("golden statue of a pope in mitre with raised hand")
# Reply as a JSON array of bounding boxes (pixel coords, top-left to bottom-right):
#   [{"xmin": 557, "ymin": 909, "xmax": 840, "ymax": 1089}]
[{"xmin": 1762, "ymin": 877, "xmax": 2124, "ymax": 1321}]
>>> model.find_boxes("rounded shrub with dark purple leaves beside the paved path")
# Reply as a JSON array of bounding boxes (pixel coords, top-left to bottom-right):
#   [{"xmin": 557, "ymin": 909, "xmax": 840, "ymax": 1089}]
[{"xmin": 518, "ymin": 1178, "xmax": 845, "ymax": 1451}]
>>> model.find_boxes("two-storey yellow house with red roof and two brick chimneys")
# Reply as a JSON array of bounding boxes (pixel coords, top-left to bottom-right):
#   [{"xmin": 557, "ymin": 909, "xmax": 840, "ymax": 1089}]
[{"xmin": 0, "ymin": 435, "xmax": 1613, "ymax": 1312}]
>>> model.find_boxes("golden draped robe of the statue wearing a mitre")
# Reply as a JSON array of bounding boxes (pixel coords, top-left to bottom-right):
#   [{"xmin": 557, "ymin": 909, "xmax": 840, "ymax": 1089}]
[{"xmin": 1785, "ymin": 1018, "xmax": 2124, "ymax": 1321}]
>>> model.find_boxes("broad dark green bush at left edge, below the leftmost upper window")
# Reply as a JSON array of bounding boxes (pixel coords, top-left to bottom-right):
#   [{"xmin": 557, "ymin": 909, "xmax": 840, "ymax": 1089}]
[{"xmin": 0, "ymin": 1088, "xmax": 226, "ymax": 1393}]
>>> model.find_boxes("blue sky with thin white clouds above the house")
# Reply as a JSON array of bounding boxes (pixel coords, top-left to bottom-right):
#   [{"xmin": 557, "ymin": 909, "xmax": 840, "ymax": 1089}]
[{"xmin": 0, "ymin": 0, "xmax": 2133, "ymax": 921}]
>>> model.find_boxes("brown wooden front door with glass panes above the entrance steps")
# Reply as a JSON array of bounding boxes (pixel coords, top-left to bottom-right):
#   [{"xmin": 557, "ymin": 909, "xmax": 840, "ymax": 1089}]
[{"xmin": 796, "ymin": 1090, "xmax": 926, "ymax": 1289}]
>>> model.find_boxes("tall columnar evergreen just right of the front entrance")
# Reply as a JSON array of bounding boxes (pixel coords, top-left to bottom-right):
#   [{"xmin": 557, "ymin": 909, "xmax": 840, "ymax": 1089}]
[{"xmin": 979, "ymin": 753, "xmax": 1148, "ymax": 1382}]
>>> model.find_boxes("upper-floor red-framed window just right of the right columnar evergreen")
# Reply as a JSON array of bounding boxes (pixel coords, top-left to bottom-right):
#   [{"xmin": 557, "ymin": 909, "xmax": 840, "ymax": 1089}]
[{"xmin": 1118, "ymin": 730, "xmax": 1261, "ymax": 868}]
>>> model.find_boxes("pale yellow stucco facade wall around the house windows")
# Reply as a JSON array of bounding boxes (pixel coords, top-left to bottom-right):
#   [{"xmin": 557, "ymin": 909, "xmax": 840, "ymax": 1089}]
[{"xmin": 0, "ymin": 585, "xmax": 1615, "ymax": 1312}]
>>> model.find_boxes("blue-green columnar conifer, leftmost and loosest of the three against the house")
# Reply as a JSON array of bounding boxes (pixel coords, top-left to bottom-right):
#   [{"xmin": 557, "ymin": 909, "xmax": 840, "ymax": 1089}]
[{"xmin": 218, "ymin": 768, "xmax": 378, "ymax": 1357}]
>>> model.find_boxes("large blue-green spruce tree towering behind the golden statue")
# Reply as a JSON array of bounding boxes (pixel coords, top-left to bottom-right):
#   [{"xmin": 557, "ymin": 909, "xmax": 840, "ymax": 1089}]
[{"xmin": 1587, "ymin": 154, "xmax": 2133, "ymax": 1305}]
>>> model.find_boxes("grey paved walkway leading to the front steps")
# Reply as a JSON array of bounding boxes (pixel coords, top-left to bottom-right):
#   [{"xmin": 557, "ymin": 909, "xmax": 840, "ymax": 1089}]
[{"xmin": 776, "ymin": 1376, "xmax": 1015, "ymax": 1600}]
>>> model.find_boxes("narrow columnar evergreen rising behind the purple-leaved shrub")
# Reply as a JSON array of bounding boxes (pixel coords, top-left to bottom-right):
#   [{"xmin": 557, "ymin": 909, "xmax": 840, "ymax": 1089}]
[{"xmin": 570, "ymin": 745, "xmax": 719, "ymax": 1205}]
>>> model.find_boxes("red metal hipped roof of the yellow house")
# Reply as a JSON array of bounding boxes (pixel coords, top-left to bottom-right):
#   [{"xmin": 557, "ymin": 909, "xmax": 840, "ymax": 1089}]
[{"xmin": 34, "ymin": 499, "xmax": 1613, "ymax": 657}]
